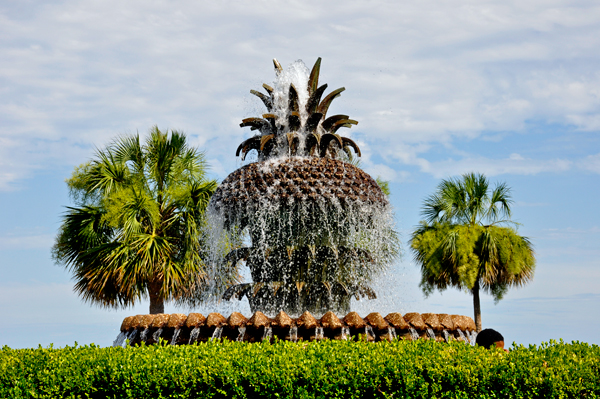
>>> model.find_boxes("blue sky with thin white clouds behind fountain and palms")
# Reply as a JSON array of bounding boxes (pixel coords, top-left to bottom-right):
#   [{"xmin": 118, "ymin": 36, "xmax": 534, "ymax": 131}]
[{"xmin": 0, "ymin": 0, "xmax": 600, "ymax": 348}]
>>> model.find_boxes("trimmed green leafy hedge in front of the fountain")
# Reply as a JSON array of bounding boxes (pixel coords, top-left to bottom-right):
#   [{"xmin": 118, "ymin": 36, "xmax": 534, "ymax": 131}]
[{"xmin": 0, "ymin": 340, "xmax": 600, "ymax": 399}]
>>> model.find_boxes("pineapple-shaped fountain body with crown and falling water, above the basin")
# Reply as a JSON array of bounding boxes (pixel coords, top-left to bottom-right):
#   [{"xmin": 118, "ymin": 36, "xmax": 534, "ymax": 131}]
[{"xmin": 207, "ymin": 58, "xmax": 399, "ymax": 315}]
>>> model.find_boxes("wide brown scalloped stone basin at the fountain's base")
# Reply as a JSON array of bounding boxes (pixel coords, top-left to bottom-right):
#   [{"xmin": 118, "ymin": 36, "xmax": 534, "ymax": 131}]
[{"xmin": 114, "ymin": 312, "xmax": 476, "ymax": 346}]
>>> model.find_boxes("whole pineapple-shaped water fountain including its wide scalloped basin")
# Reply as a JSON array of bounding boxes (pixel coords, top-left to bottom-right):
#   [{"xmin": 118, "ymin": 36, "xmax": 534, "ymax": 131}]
[{"xmin": 115, "ymin": 58, "xmax": 475, "ymax": 344}]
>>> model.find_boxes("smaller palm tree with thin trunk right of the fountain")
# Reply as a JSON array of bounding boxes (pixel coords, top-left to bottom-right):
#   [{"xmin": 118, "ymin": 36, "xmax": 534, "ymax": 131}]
[{"xmin": 410, "ymin": 173, "xmax": 535, "ymax": 331}]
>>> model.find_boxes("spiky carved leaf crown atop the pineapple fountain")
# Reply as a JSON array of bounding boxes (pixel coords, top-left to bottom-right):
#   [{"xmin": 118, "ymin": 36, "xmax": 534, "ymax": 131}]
[{"xmin": 235, "ymin": 57, "xmax": 361, "ymax": 160}]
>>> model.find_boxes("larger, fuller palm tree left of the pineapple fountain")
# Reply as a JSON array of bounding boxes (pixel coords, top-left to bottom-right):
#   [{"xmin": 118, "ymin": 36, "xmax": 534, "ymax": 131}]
[{"xmin": 53, "ymin": 126, "xmax": 223, "ymax": 313}]
